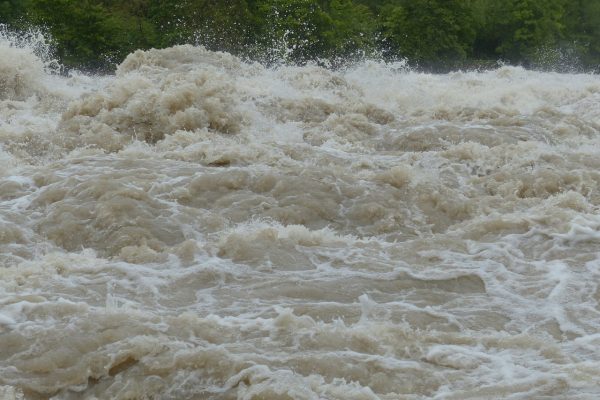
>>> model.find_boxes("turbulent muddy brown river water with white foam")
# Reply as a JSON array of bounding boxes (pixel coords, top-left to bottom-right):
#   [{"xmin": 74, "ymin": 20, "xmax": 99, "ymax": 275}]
[{"xmin": 0, "ymin": 32, "xmax": 600, "ymax": 400}]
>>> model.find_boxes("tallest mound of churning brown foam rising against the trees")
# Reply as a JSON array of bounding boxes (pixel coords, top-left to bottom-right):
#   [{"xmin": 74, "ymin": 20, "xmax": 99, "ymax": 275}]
[{"xmin": 59, "ymin": 46, "xmax": 242, "ymax": 151}]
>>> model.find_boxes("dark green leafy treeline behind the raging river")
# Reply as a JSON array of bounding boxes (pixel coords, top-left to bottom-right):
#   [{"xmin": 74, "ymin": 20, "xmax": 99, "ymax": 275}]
[{"xmin": 0, "ymin": 0, "xmax": 600, "ymax": 71}]
